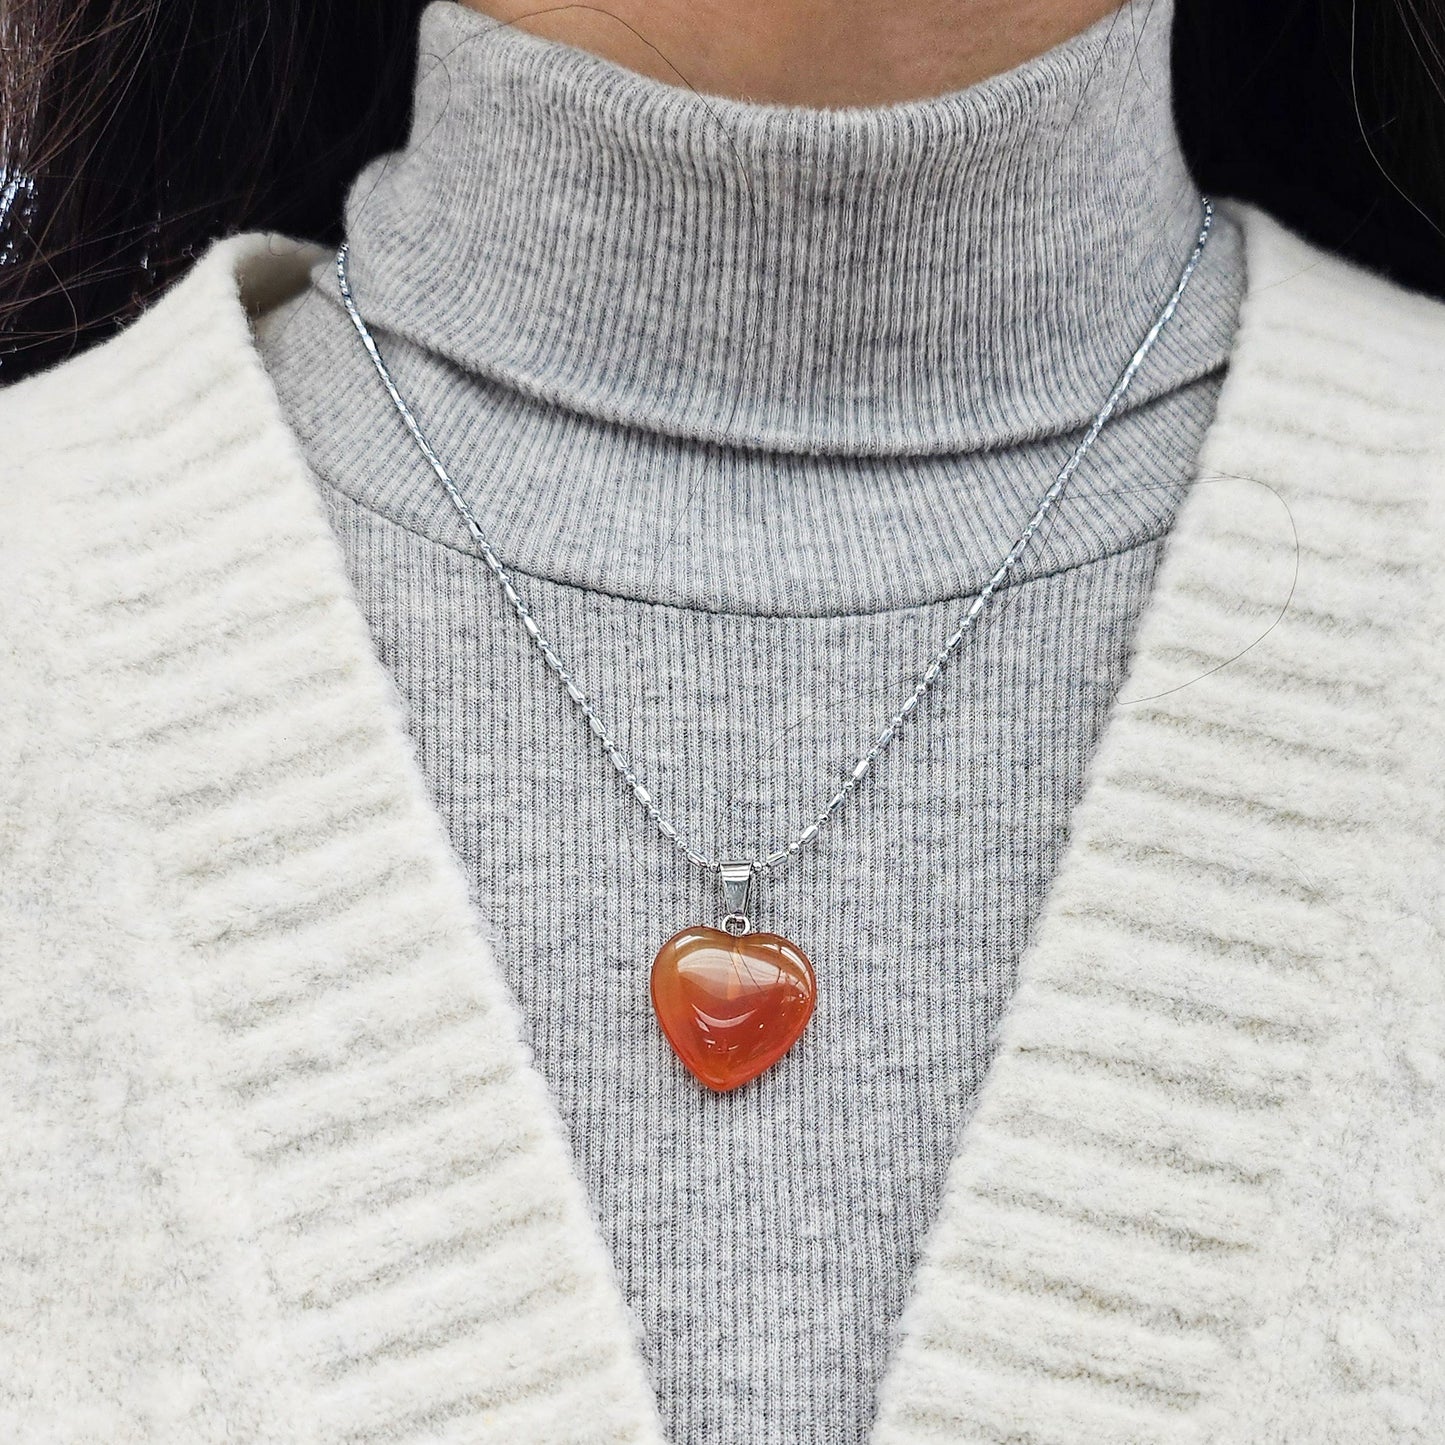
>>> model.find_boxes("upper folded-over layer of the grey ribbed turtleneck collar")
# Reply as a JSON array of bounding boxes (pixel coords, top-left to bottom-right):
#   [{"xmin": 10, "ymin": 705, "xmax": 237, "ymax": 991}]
[{"xmin": 335, "ymin": 0, "xmax": 1231, "ymax": 455}]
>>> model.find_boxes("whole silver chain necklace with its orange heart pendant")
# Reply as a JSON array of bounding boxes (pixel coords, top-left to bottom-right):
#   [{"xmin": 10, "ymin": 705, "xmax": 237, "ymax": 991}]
[{"xmin": 337, "ymin": 197, "xmax": 1214, "ymax": 1092}]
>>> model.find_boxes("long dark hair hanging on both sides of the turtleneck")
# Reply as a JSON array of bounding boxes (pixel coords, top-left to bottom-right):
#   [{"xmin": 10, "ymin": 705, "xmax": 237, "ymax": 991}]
[{"xmin": 0, "ymin": 0, "xmax": 1445, "ymax": 381}]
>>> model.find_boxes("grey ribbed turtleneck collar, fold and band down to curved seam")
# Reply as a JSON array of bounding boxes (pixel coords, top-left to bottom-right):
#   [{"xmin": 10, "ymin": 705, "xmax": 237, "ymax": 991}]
[{"xmin": 257, "ymin": 0, "xmax": 1243, "ymax": 616}]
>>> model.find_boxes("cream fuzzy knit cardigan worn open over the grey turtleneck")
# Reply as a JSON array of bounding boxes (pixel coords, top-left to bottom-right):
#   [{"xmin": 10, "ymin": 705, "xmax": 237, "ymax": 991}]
[{"xmin": 0, "ymin": 207, "xmax": 1445, "ymax": 1445}]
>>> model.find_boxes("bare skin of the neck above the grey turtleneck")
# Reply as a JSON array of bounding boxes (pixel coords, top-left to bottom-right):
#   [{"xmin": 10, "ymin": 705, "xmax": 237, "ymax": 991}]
[{"xmin": 462, "ymin": 0, "xmax": 1118, "ymax": 108}]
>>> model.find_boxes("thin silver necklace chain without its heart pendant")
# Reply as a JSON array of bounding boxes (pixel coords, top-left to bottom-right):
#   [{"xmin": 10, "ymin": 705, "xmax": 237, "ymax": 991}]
[{"xmin": 337, "ymin": 197, "xmax": 1214, "ymax": 890}]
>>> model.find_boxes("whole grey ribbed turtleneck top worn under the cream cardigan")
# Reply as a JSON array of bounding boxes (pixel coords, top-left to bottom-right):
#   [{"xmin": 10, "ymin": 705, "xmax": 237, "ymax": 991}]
[{"xmin": 262, "ymin": 0, "xmax": 1243, "ymax": 1445}]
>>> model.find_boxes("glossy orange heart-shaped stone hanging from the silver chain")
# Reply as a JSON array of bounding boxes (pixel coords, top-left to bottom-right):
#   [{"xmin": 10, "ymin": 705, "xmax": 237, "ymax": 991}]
[{"xmin": 652, "ymin": 926, "xmax": 818, "ymax": 1094}]
